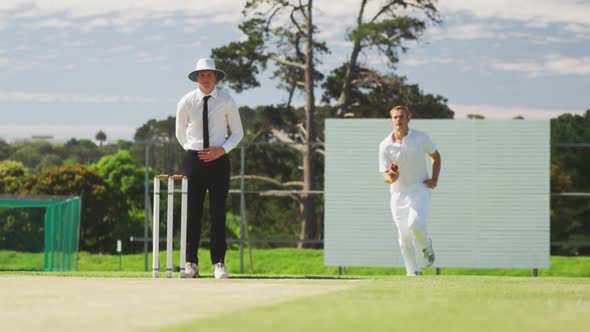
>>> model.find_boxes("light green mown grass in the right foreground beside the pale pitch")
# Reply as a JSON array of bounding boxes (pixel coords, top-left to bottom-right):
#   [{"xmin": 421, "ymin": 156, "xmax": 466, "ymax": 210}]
[{"xmin": 164, "ymin": 276, "xmax": 590, "ymax": 332}]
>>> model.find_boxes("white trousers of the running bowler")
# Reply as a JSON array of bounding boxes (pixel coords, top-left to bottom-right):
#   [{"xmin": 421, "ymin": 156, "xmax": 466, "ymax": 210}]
[{"xmin": 391, "ymin": 187, "xmax": 431, "ymax": 275}]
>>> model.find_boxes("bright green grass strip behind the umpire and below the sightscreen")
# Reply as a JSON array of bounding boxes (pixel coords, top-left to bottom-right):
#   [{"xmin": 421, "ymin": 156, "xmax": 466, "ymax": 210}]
[{"xmin": 0, "ymin": 249, "xmax": 590, "ymax": 277}]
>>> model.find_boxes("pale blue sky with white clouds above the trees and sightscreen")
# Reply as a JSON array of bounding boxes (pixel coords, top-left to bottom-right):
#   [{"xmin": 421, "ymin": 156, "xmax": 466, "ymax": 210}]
[{"xmin": 0, "ymin": 0, "xmax": 590, "ymax": 141}]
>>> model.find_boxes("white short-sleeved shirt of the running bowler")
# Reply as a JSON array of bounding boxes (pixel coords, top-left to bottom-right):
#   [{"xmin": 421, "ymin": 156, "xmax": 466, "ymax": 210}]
[{"xmin": 379, "ymin": 128, "xmax": 436, "ymax": 193}]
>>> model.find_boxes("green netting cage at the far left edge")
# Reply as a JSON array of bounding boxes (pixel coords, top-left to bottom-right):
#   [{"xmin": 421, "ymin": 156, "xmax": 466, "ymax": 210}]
[{"xmin": 0, "ymin": 195, "xmax": 81, "ymax": 272}]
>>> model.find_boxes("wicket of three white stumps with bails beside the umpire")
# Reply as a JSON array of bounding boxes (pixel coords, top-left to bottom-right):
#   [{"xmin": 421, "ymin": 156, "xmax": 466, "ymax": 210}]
[{"xmin": 152, "ymin": 174, "xmax": 188, "ymax": 278}]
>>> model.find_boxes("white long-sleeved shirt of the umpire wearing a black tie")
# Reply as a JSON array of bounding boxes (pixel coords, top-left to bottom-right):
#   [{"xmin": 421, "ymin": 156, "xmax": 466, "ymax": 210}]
[{"xmin": 176, "ymin": 88, "xmax": 244, "ymax": 153}]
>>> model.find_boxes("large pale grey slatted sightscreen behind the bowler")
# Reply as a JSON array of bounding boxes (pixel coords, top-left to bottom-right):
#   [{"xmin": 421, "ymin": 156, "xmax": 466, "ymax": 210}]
[{"xmin": 324, "ymin": 119, "xmax": 550, "ymax": 268}]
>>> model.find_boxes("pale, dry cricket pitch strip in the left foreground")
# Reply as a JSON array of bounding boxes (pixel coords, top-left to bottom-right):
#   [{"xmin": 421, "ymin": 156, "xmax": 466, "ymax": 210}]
[{"xmin": 0, "ymin": 275, "xmax": 361, "ymax": 332}]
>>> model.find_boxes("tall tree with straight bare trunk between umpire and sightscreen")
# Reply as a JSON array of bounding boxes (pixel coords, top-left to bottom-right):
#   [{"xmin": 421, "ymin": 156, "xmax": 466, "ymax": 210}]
[{"xmin": 212, "ymin": 0, "xmax": 327, "ymax": 244}]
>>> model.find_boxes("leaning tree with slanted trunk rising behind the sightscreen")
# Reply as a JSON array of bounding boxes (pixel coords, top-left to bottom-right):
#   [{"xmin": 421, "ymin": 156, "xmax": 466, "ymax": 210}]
[{"xmin": 336, "ymin": 0, "xmax": 440, "ymax": 116}]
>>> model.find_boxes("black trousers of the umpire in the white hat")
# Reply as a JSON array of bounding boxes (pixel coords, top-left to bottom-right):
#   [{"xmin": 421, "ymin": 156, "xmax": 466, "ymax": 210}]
[{"xmin": 183, "ymin": 150, "xmax": 230, "ymax": 264}]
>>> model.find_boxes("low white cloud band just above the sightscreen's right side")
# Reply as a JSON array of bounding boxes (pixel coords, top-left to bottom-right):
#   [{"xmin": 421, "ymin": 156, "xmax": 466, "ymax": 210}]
[{"xmin": 449, "ymin": 104, "xmax": 584, "ymax": 120}]
